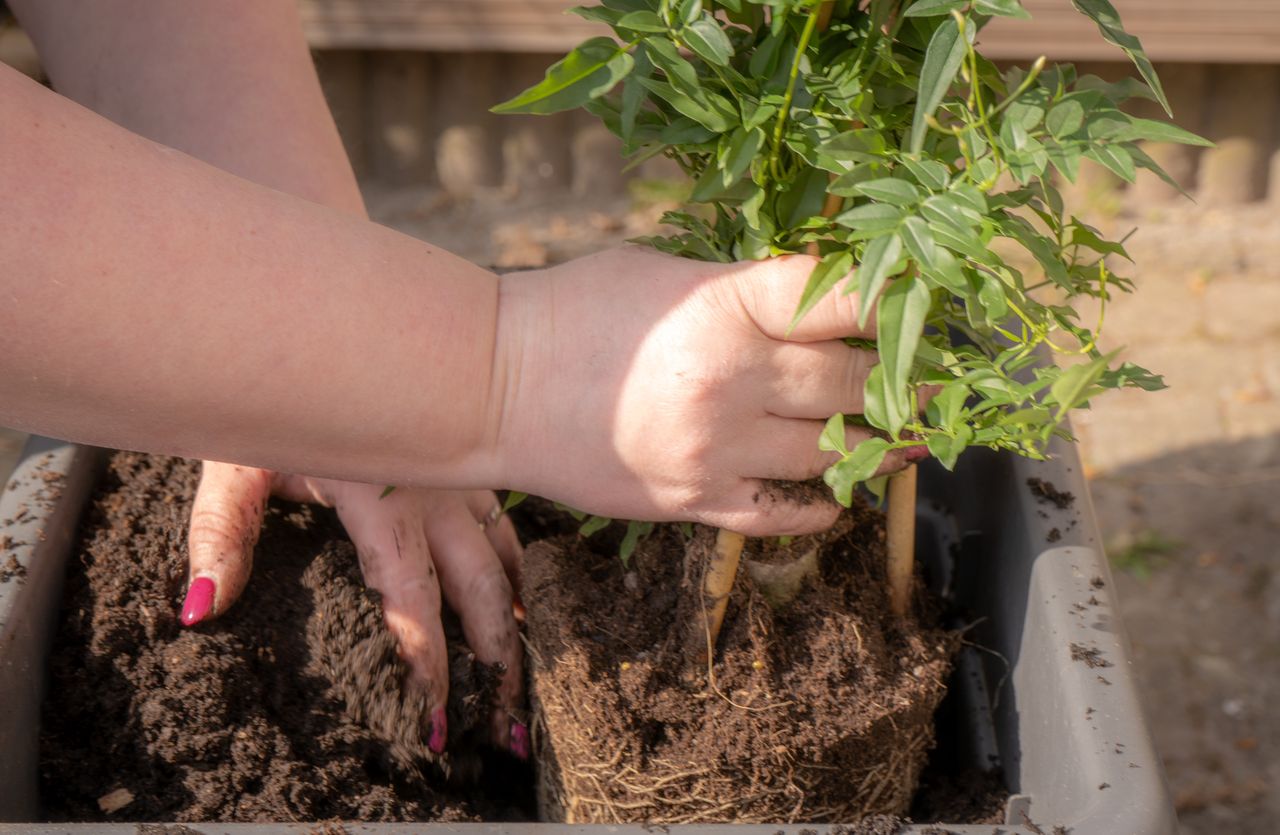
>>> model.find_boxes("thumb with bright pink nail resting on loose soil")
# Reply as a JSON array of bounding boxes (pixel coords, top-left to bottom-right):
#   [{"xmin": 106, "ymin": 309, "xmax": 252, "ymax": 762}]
[{"xmin": 180, "ymin": 461, "xmax": 271, "ymax": 626}]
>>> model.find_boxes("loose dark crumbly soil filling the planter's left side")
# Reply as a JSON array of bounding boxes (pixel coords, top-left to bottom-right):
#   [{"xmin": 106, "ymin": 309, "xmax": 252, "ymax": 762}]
[{"xmin": 41, "ymin": 453, "xmax": 531, "ymax": 821}]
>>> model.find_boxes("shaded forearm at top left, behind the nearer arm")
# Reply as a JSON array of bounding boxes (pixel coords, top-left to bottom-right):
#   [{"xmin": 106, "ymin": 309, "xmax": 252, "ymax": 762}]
[{"xmin": 10, "ymin": 0, "xmax": 364, "ymax": 214}]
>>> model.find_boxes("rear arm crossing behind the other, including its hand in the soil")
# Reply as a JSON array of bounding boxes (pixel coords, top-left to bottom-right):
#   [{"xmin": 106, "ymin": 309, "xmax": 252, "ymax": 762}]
[{"xmin": 5, "ymin": 0, "xmax": 524, "ymax": 749}]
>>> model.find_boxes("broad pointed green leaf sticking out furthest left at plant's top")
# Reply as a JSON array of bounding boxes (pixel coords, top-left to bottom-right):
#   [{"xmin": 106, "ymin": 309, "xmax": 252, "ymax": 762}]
[{"xmin": 493, "ymin": 37, "xmax": 635, "ymax": 114}]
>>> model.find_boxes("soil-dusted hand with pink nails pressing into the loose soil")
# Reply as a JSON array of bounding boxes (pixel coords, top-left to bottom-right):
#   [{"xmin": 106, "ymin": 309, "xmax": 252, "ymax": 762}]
[{"xmin": 182, "ymin": 461, "xmax": 529, "ymax": 758}]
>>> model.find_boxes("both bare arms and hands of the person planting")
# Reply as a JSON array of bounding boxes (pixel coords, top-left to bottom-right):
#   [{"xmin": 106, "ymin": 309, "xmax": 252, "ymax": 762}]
[{"xmin": 0, "ymin": 0, "xmax": 902, "ymax": 753}]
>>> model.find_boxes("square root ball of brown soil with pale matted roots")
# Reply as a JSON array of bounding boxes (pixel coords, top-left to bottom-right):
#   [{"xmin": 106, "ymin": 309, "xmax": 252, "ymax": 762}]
[{"xmin": 524, "ymin": 497, "xmax": 954, "ymax": 823}]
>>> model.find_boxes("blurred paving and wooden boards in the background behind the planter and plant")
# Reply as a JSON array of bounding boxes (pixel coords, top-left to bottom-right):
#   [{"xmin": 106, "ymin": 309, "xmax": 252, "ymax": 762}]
[{"xmin": 0, "ymin": 0, "xmax": 1280, "ymax": 835}]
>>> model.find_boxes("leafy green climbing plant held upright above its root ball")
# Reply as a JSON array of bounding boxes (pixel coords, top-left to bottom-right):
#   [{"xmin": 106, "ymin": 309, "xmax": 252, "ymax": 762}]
[{"xmin": 494, "ymin": 0, "xmax": 1206, "ymax": 503}]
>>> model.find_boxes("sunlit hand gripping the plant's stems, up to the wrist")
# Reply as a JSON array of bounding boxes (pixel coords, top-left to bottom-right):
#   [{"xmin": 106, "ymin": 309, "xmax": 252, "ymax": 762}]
[{"xmin": 494, "ymin": 247, "xmax": 923, "ymax": 535}]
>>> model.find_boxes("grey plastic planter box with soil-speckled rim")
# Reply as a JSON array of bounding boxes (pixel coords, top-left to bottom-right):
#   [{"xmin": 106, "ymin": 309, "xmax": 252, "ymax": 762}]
[{"xmin": 0, "ymin": 438, "xmax": 1176, "ymax": 835}]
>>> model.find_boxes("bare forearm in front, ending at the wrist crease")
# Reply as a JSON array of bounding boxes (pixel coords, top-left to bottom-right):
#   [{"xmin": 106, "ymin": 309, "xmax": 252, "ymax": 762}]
[{"xmin": 0, "ymin": 68, "xmax": 502, "ymax": 485}]
